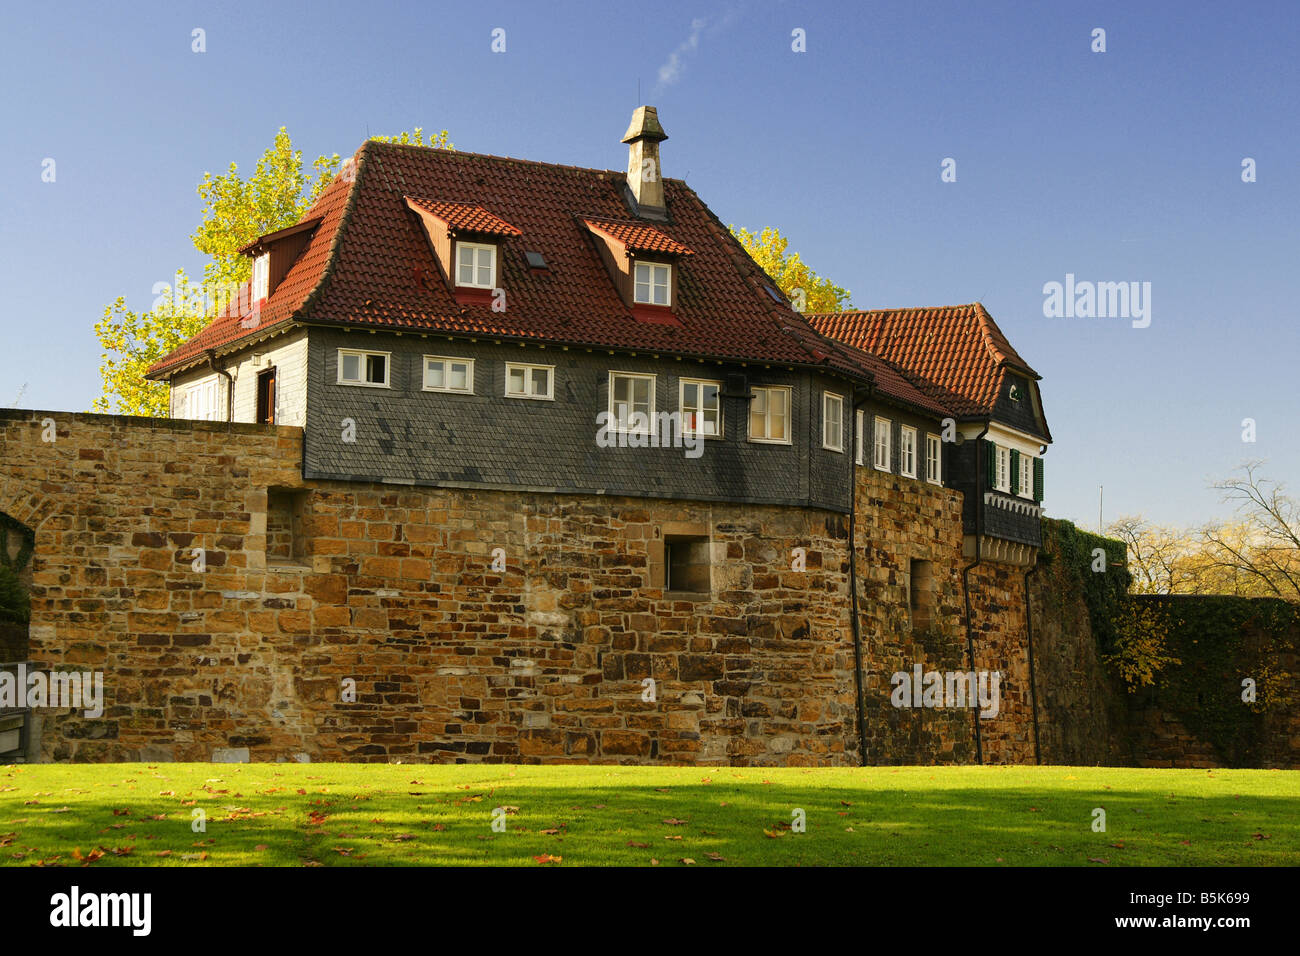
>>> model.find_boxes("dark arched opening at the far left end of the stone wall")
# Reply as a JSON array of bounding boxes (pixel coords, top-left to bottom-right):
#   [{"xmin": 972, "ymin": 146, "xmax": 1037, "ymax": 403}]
[{"xmin": 0, "ymin": 511, "xmax": 36, "ymax": 763}]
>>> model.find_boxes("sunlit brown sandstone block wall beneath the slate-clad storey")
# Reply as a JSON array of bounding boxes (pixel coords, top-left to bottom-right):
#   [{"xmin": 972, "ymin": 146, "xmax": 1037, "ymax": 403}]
[{"xmin": 0, "ymin": 410, "xmax": 1045, "ymax": 765}]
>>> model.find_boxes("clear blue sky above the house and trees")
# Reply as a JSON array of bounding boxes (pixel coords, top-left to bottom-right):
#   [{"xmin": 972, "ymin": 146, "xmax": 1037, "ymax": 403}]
[{"xmin": 0, "ymin": 0, "xmax": 1300, "ymax": 527}]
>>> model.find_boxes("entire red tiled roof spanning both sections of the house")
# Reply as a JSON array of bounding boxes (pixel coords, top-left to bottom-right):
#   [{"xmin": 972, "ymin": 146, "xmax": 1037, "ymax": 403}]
[{"xmin": 142, "ymin": 142, "xmax": 1032, "ymax": 429}]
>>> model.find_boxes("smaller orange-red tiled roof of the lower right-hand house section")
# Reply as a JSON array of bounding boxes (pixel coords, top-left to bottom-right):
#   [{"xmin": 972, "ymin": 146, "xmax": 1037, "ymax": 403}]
[{"xmin": 807, "ymin": 302, "xmax": 1050, "ymax": 440}]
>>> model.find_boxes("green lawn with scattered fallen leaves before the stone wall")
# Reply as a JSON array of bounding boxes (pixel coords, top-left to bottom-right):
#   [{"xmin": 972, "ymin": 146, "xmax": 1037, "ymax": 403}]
[{"xmin": 0, "ymin": 763, "xmax": 1300, "ymax": 866}]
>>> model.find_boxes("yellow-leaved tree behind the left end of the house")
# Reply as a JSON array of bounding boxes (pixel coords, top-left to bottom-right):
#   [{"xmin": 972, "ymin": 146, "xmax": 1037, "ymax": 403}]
[{"xmin": 94, "ymin": 126, "xmax": 455, "ymax": 416}]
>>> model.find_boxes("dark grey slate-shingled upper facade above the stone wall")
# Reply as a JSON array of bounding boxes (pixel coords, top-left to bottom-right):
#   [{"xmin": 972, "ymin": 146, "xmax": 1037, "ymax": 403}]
[{"xmin": 297, "ymin": 326, "xmax": 937, "ymax": 511}]
